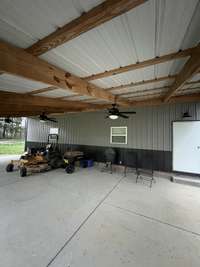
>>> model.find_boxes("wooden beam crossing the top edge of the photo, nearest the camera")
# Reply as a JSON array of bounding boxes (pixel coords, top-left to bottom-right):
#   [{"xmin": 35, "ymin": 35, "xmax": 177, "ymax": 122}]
[{"xmin": 26, "ymin": 0, "xmax": 147, "ymax": 56}]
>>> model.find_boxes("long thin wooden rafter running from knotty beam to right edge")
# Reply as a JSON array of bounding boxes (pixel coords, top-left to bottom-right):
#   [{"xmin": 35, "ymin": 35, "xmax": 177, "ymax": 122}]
[{"xmin": 83, "ymin": 47, "xmax": 196, "ymax": 81}]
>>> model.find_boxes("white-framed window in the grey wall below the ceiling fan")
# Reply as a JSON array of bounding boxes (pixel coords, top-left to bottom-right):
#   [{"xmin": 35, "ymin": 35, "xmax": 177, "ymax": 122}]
[{"xmin": 110, "ymin": 126, "xmax": 127, "ymax": 144}]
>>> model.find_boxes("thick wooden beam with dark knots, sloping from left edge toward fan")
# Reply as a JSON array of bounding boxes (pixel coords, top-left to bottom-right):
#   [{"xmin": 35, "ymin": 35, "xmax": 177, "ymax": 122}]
[{"xmin": 0, "ymin": 41, "xmax": 129, "ymax": 106}]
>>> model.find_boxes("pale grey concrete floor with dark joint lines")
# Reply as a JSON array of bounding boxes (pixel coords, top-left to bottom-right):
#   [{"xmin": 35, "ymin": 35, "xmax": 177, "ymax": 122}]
[{"xmin": 0, "ymin": 157, "xmax": 200, "ymax": 267}]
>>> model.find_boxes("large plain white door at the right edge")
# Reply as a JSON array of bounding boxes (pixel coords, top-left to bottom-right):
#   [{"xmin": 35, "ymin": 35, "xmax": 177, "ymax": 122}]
[{"xmin": 173, "ymin": 121, "xmax": 200, "ymax": 174}]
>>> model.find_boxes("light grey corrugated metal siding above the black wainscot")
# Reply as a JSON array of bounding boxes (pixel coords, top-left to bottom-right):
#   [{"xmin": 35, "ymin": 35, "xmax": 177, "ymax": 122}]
[{"xmin": 27, "ymin": 103, "xmax": 200, "ymax": 151}]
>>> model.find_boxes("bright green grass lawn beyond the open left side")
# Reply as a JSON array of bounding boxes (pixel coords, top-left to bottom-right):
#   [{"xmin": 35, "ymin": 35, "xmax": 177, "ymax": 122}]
[{"xmin": 0, "ymin": 140, "xmax": 24, "ymax": 155}]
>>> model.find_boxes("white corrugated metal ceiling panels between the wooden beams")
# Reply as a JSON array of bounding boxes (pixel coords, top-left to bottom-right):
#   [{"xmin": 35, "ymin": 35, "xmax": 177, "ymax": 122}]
[{"xmin": 0, "ymin": 0, "xmax": 200, "ymax": 102}]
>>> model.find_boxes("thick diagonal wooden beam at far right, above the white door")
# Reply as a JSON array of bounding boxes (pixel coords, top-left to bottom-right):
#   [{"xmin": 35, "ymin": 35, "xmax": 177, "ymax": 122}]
[{"xmin": 163, "ymin": 45, "xmax": 200, "ymax": 102}]
